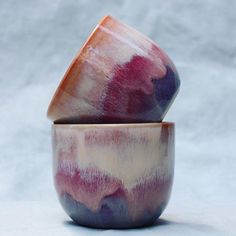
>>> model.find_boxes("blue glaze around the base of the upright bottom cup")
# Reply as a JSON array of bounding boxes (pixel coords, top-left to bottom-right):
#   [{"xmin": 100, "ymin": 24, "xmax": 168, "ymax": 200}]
[{"xmin": 60, "ymin": 193, "xmax": 166, "ymax": 228}]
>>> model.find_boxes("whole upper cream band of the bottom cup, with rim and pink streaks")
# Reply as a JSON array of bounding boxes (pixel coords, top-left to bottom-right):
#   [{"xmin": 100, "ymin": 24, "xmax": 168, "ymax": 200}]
[{"xmin": 53, "ymin": 122, "xmax": 174, "ymax": 189}]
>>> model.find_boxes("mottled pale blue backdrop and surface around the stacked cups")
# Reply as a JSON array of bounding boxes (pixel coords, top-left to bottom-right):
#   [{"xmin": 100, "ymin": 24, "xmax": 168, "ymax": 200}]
[{"xmin": 0, "ymin": 0, "xmax": 236, "ymax": 235}]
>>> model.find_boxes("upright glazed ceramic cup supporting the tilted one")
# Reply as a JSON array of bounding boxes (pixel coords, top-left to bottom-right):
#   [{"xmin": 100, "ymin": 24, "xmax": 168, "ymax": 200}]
[{"xmin": 52, "ymin": 123, "xmax": 174, "ymax": 228}]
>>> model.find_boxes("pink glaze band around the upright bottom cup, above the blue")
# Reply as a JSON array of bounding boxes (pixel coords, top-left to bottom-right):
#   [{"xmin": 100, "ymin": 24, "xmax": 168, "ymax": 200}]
[{"xmin": 55, "ymin": 165, "xmax": 173, "ymax": 220}]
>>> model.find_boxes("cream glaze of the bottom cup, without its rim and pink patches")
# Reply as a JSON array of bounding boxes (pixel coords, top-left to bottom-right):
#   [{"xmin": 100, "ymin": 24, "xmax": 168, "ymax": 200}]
[{"xmin": 54, "ymin": 125, "xmax": 174, "ymax": 190}]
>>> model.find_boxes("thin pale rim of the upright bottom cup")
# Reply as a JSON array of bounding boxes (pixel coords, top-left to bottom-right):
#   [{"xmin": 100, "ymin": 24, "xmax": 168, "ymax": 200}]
[{"xmin": 52, "ymin": 121, "xmax": 175, "ymax": 129}]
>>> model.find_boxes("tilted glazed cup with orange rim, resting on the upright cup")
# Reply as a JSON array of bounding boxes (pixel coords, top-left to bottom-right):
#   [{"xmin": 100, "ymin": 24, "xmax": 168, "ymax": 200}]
[{"xmin": 47, "ymin": 16, "xmax": 180, "ymax": 123}]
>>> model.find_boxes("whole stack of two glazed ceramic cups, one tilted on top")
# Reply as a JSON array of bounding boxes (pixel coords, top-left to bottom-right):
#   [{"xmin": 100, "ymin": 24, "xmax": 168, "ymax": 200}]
[{"xmin": 47, "ymin": 16, "xmax": 180, "ymax": 228}]
